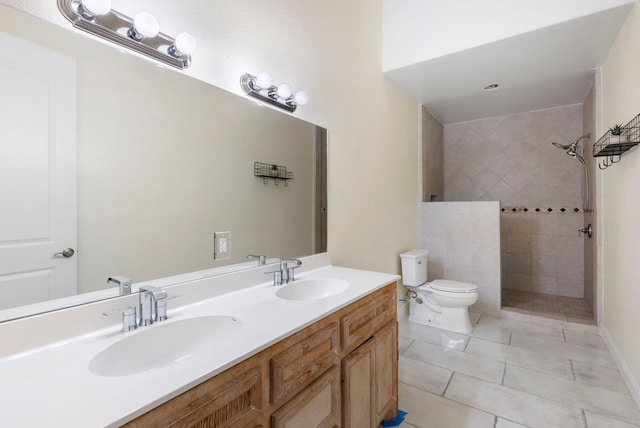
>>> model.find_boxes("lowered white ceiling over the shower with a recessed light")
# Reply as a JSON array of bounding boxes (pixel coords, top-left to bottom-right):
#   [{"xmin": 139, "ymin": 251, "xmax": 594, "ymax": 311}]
[{"xmin": 385, "ymin": 0, "xmax": 634, "ymax": 124}]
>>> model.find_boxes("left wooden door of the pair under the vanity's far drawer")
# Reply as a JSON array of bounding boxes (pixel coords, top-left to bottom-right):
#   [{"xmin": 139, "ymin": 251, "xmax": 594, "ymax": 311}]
[{"xmin": 342, "ymin": 339, "xmax": 377, "ymax": 428}]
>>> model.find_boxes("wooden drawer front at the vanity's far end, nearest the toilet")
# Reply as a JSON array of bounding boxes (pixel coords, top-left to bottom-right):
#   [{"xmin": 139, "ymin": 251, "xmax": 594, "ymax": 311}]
[{"xmin": 340, "ymin": 284, "xmax": 398, "ymax": 351}]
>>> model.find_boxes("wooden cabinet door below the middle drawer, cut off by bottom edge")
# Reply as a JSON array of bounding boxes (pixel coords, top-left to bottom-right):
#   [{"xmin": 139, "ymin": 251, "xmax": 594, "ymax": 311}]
[{"xmin": 271, "ymin": 366, "xmax": 340, "ymax": 428}]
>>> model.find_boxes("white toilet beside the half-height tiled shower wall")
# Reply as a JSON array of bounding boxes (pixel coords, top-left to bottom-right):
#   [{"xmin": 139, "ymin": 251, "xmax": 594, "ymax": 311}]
[{"xmin": 400, "ymin": 249, "xmax": 478, "ymax": 334}]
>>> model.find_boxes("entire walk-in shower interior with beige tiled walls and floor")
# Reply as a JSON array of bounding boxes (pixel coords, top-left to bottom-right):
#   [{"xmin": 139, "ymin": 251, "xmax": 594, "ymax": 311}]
[{"xmin": 444, "ymin": 97, "xmax": 596, "ymax": 323}]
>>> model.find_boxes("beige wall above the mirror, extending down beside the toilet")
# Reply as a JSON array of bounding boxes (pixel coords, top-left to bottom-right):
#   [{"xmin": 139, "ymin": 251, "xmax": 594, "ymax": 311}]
[{"xmin": 2, "ymin": 0, "xmax": 420, "ymax": 273}]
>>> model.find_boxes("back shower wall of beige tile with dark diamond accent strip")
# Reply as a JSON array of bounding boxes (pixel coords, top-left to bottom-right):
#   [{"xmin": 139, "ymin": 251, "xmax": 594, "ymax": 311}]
[{"xmin": 444, "ymin": 105, "xmax": 593, "ymax": 297}]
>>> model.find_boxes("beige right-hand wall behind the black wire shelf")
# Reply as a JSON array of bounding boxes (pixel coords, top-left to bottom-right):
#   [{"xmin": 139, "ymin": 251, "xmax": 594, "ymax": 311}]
[{"xmin": 602, "ymin": 4, "xmax": 640, "ymax": 381}]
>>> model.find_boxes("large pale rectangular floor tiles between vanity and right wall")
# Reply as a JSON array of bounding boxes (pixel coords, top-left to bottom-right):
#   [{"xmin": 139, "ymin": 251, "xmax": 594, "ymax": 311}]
[{"xmin": 399, "ymin": 314, "xmax": 640, "ymax": 428}]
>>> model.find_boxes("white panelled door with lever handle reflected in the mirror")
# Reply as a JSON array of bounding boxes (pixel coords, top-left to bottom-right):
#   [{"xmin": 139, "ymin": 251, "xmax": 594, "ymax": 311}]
[{"xmin": 0, "ymin": 32, "xmax": 77, "ymax": 309}]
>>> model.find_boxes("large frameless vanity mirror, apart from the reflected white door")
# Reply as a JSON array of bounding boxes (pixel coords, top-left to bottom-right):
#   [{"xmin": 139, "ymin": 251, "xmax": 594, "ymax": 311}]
[{"xmin": 0, "ymin": 5, "xmax": 326, "ymax": 321}]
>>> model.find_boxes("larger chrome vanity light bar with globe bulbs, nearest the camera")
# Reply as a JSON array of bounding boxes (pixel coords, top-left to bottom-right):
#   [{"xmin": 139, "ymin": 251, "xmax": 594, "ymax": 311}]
[{"xmin": 58, "ymin": 0, "xmax": 198, "ymax": 69}]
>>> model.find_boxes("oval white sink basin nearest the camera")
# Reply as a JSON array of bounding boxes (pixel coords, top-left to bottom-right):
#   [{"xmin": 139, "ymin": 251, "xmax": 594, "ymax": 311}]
[{"xmin": 89, "ymin": 316, "xmax": 243, "ymax": 377}]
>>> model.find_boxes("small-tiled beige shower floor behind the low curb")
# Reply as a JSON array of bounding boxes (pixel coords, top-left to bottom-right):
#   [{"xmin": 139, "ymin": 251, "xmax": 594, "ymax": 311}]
[{"xmin": 502, "ymin": 288, "xmax": 594, "ymax": 323}]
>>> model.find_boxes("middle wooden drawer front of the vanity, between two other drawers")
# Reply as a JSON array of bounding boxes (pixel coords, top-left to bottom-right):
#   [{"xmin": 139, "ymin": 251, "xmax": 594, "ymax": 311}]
[{"xmin": 270, "ymin": 322, "xmax": 338, "ymax": 403}]
